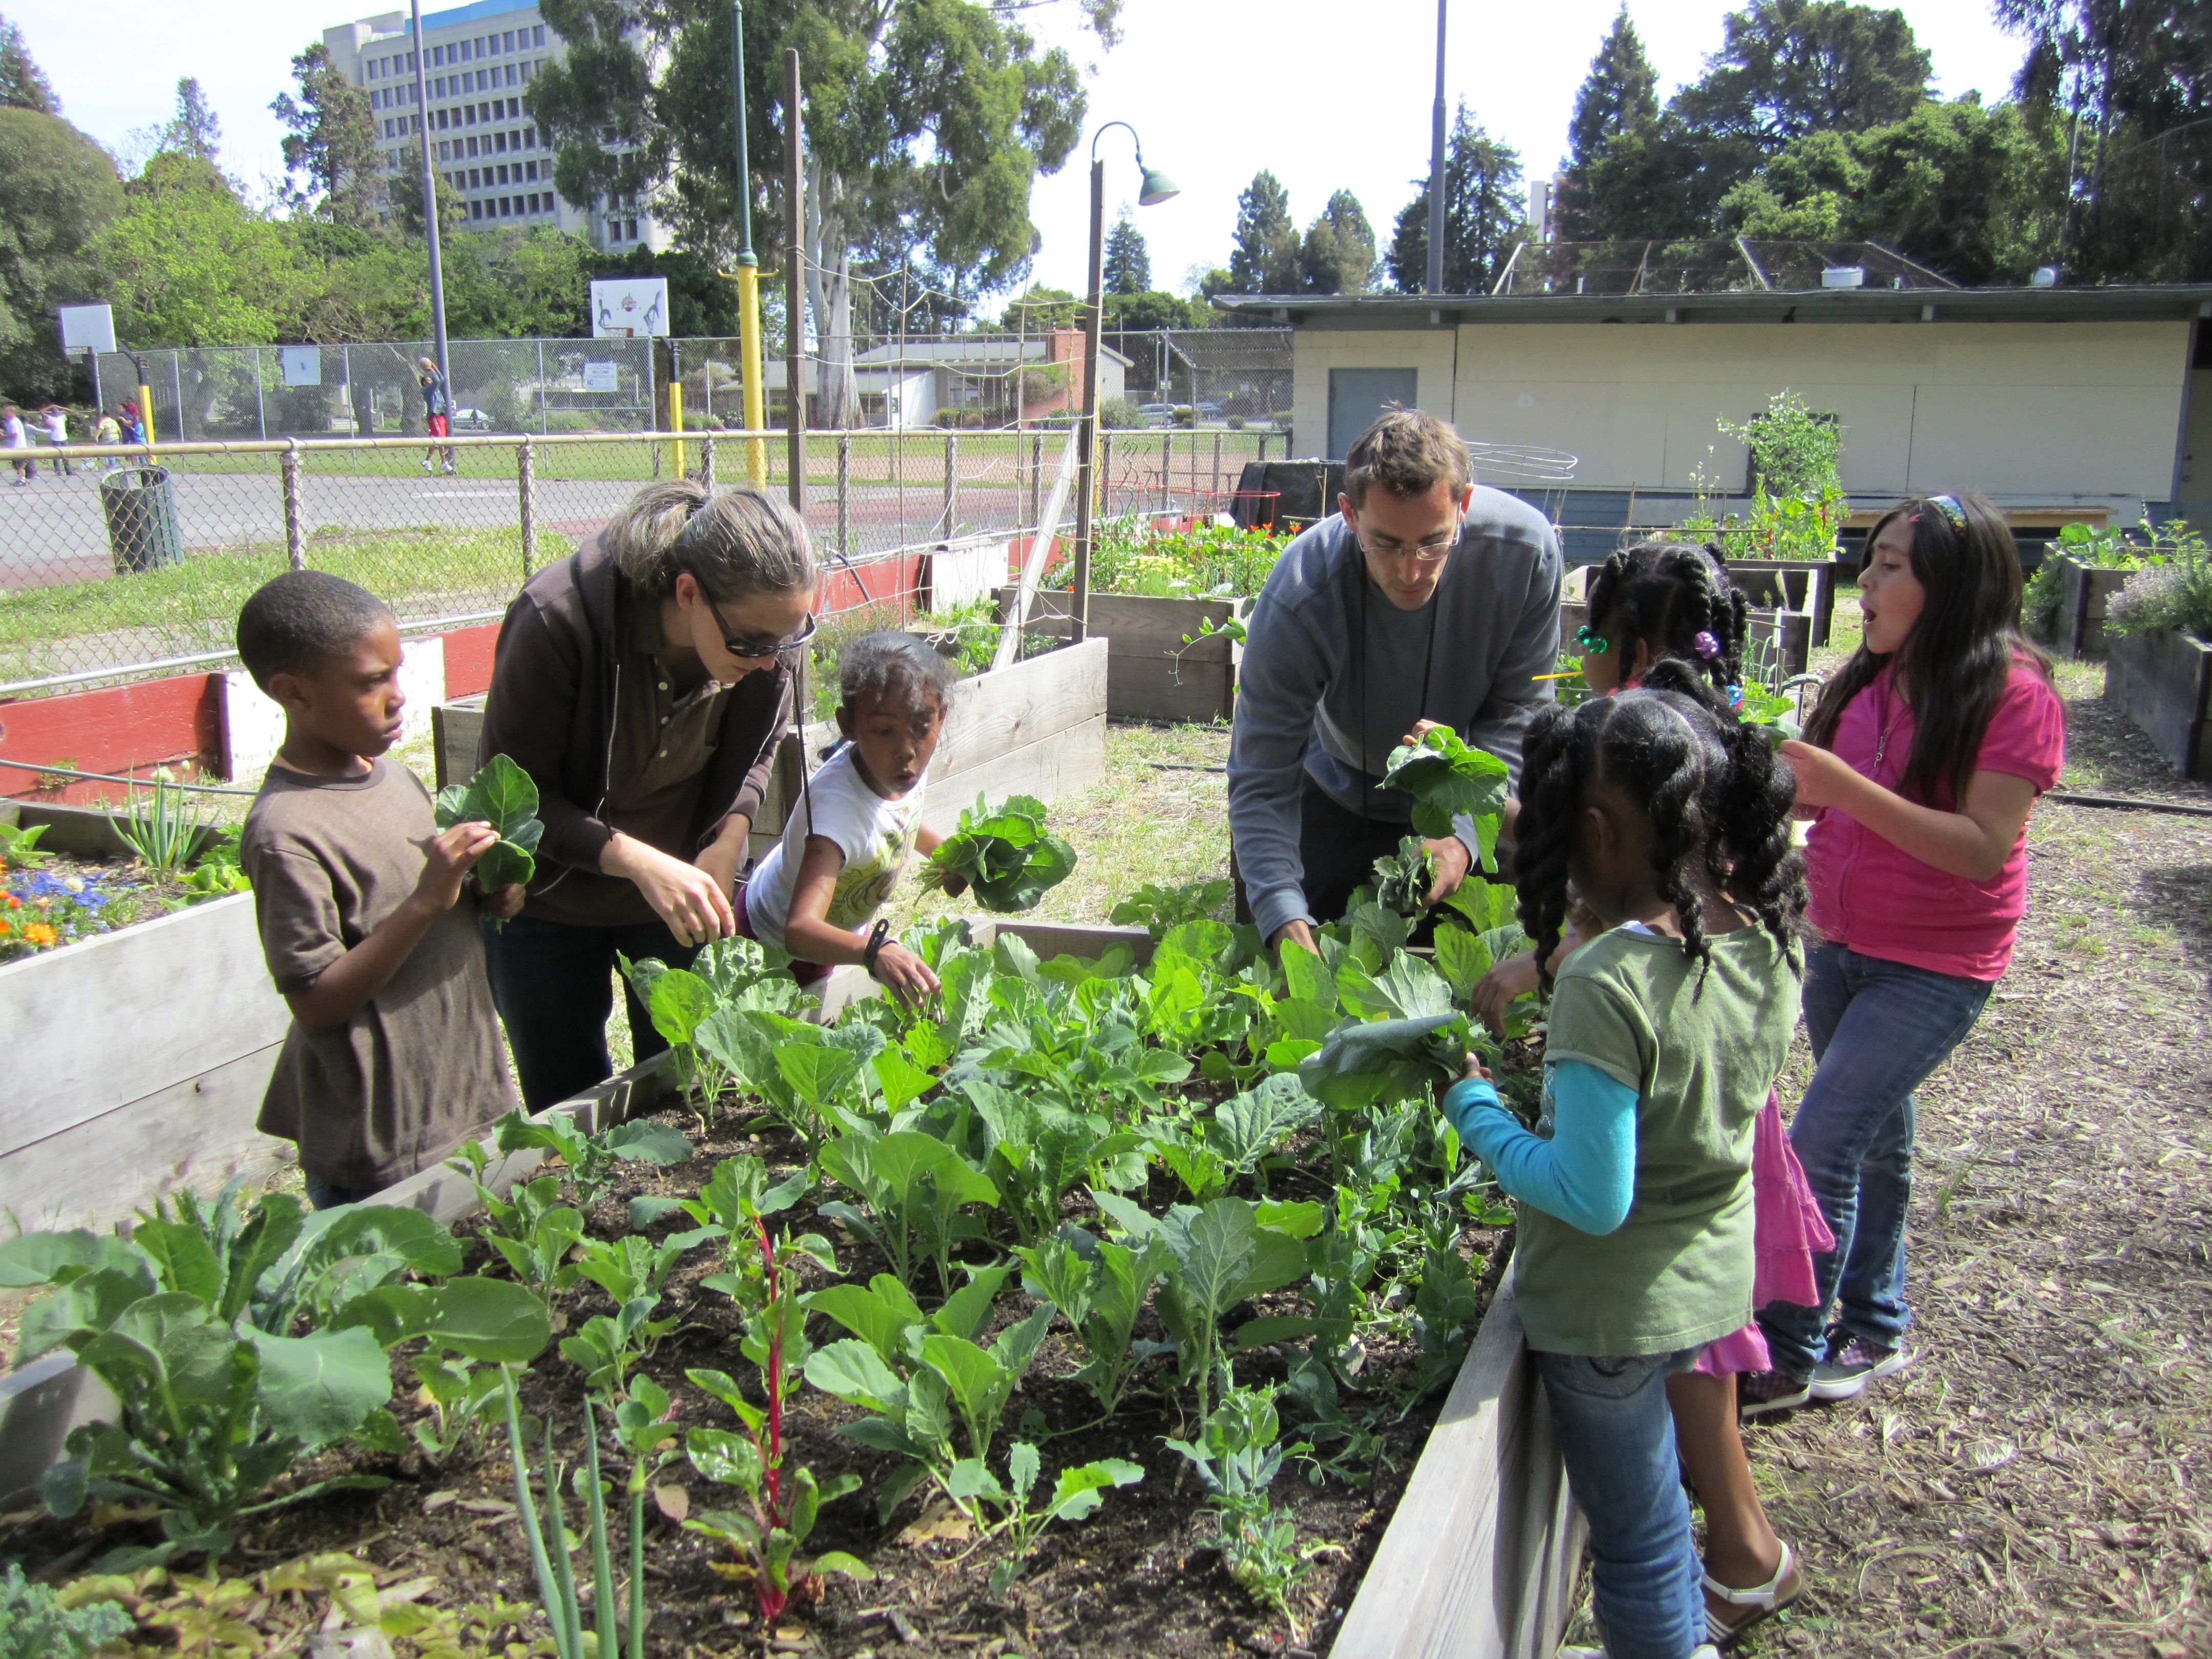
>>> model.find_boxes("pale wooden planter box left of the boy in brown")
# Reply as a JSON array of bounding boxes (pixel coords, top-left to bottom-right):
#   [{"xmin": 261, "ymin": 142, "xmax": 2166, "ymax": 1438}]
[{"xmin": 0, "ymin": 898, "xmax": 292, "ymax": 1232}]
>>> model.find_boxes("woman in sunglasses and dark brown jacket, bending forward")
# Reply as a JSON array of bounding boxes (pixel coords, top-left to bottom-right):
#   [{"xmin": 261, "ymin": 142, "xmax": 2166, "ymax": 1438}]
[{"xmin": 480, "ymin": 482, "xmax": 816, "ymax": 1111}]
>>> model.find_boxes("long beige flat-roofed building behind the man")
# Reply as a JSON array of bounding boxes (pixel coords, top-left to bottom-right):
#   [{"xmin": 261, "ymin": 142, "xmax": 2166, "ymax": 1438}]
[{"xmin": 1221, "ymin": 285, "xmax": 2212, "ymax": 533}]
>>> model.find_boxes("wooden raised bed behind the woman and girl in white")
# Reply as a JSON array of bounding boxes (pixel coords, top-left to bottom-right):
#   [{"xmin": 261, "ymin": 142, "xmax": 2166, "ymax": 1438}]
[{"xmin": 431, "ymin": 639, "xmax": 1108, "ymax": 858}]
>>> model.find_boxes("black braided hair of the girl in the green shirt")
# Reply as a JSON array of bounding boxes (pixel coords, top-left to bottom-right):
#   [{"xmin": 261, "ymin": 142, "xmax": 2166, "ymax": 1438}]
[{"xmin": 1513, "ymin": 659, "xmax": 1805, "ymax": 984}]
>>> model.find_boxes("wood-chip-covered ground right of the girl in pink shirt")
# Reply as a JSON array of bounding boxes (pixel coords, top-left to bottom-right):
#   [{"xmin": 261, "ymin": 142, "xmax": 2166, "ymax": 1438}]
[{"xmin": 1743, "ymin": 666, "xmax": 2212, "ymax": 1659}]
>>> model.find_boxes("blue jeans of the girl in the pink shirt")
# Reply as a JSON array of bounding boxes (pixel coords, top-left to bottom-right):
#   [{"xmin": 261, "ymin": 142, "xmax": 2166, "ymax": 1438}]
[{"xmin": 1758, "ymin": 945, "xmax": 1995, "ymax": 1376}]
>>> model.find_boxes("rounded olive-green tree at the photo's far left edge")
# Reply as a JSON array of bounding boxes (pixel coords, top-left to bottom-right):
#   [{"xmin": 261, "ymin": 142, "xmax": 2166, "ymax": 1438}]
[{"xmin": 0, "ymin": 106, "xmax": 124, "ymax": 398}]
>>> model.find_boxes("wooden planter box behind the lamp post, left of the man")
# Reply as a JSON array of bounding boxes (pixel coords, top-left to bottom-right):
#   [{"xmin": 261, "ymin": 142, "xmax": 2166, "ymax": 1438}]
[{"xmin": 997, "ymin": 588, "xmax": 1252, "ymax": 721}]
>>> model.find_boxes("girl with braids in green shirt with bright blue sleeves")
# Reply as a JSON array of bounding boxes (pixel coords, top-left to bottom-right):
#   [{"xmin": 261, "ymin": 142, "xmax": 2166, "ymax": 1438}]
[{"xmin": 1444, "ymin": 670, "xmax": 1803, "ymax": 1659}]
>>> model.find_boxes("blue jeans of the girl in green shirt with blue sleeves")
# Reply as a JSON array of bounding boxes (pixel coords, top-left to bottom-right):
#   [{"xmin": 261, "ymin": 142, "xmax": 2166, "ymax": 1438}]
[{"xmin": 1535, "ymin": 1347, "xmax": 1706, "ymax": 1659}]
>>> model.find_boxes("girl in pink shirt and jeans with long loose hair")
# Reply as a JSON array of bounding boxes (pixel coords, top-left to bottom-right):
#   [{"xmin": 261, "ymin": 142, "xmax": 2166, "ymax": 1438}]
[{"xmin": 1739, "ymin": 496, "xmax": 2066, "ymax": 1416}]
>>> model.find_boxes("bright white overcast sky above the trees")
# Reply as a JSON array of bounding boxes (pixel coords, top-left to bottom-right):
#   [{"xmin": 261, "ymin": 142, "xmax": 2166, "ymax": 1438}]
[{"xmin": 13, "ymin": 0, "xmax": 2022, "ymax": 305}]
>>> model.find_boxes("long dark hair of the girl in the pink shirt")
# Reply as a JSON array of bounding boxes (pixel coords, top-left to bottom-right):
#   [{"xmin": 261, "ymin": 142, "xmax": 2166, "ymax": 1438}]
[{"xmin": 1805, "ymin": 496, "xmax": 2051, "ymax": 805}]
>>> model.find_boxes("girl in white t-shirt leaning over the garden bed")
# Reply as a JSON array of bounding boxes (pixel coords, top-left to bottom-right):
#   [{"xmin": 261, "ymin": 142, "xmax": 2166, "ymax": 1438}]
[{"xmin": 737, "ymin": 633, "xmax": 953, "ymax": 1002}]
